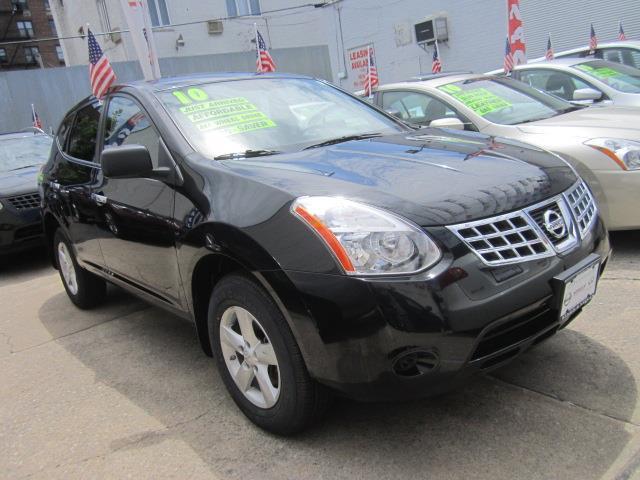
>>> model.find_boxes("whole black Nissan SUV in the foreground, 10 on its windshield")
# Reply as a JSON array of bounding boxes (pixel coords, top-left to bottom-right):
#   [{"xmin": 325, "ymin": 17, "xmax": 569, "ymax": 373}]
[{"xmin": 42, "ymin": 74, "xmax": 609, "ymax": 434}]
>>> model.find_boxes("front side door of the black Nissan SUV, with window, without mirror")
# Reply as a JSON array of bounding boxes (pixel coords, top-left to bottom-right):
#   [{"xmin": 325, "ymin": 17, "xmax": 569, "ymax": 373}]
[{"xmin": 94, "ymin": 94, "xmax": 184, "ymax": 307}]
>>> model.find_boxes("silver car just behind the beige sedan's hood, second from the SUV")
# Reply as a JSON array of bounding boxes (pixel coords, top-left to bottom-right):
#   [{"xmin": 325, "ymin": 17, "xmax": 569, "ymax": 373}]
[{"xmin": 491, "ymin": 58, "xmax": 640, "ymax": 107}]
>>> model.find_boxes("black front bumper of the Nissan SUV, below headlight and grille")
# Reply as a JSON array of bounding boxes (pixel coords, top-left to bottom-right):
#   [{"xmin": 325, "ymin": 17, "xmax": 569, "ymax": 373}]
[{"xmin": 278, "ymin": 219, "xmax": 610, "ymax": 401}]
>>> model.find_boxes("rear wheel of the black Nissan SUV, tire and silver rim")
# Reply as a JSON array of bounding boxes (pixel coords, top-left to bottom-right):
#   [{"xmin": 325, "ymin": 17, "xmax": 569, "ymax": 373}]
[{"xmin": 53, "ymin": 229, "xmax": 107, "ymax": 310}]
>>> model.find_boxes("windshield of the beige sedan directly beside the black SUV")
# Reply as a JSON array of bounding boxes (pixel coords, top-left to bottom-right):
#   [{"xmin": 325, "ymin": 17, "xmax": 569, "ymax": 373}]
[{"xmin": 438, "ymin": 78, "xmax": 576, "ymax": 125}]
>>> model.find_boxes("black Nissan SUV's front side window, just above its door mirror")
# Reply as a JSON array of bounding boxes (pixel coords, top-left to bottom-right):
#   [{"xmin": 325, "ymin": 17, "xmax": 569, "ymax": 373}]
[{"xmin": 104, "ymin": 96, "xmax": 162, "ymax": 168}]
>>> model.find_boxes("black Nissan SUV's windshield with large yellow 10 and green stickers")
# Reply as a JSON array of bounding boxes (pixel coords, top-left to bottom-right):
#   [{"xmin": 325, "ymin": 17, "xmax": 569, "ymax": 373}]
[{"xmin": 159, "ymin": 78, "xmax": 405, "ymax": 158}]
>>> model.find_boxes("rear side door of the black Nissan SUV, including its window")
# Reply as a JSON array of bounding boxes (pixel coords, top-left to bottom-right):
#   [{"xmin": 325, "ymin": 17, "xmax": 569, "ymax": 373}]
[{"xmin": 45, "ymin": 101, "xmax": 104, "ymax": 266}]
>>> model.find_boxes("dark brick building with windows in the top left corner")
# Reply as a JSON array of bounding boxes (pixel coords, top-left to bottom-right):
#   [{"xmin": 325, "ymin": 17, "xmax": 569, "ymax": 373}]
[{"xmin": 0, "ymin": 0, "xmax": 65, "ymax": 70}]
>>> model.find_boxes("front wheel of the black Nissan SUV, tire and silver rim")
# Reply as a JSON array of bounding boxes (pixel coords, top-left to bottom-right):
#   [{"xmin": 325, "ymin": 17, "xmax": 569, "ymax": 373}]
[{"xmin": 208, "ymin": 274, "xmax": 330, "ymax": 435}]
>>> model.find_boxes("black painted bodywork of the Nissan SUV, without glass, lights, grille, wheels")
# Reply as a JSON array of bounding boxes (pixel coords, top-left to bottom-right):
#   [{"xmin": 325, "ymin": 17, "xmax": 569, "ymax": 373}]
[{"xmin": 43, "ymin": 75, "xmax": 609, "ymax": 400}]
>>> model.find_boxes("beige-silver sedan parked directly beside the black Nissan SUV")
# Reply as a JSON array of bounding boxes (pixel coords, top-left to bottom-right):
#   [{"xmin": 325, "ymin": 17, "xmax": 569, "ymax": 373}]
[{"xmin": 372, "ymin": 74, "xmax": 640, "ymax": 230}]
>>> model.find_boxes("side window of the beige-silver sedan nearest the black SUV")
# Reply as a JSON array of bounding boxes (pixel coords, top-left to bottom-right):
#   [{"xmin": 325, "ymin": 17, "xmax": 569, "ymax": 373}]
[{"xmin": 377, "ymin": 90, "xmax": 476, "ymax": 131}]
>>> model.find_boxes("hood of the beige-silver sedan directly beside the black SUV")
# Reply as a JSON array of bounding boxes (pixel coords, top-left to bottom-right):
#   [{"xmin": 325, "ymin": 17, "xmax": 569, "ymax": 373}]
[{"xmin": 518, "ymin": 106, "xmax": 640, "ymax": 140}]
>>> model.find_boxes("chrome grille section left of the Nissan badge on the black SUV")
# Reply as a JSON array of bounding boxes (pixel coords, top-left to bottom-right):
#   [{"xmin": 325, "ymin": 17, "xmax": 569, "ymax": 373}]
[{"xmin": 448, "ymin": 212, "xmax": 554, "ymax": 265}]
